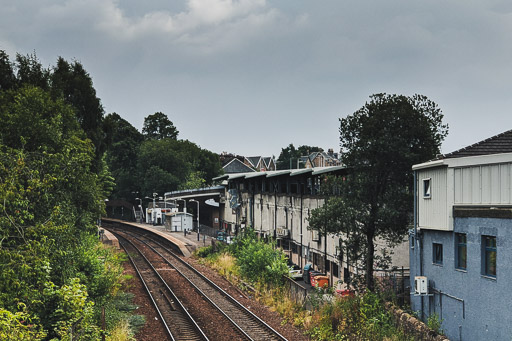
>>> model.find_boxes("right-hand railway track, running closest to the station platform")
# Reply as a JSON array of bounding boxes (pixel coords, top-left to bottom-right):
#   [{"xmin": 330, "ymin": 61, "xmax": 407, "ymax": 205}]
[{"xmin": 106, "ymin": 223, "xmax": 286, "ymax": 341}]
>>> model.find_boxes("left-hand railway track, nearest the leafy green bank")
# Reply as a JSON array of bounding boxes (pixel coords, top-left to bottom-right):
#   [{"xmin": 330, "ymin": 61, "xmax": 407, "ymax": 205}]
[{"xmin": 117, "ymin": 235, "xmax": 208, "ymax": 341}]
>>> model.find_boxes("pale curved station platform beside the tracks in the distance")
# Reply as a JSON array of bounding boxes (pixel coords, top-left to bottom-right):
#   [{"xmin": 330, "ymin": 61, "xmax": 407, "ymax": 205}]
[{"xmin": 101, "ymin": 218, "xmax": 213, "ymax": 257}]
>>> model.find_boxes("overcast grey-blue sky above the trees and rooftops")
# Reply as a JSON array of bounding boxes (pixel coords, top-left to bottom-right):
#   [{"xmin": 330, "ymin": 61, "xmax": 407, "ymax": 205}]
[{"xmin": 0, "ymin": 0, "xmax": 512, "ymax": 157}]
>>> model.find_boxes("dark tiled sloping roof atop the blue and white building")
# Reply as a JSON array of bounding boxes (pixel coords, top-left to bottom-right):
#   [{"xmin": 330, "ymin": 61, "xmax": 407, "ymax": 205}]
[{"xmin": 440, "ymin": 130, "xmax": 512, "ymax": 159}]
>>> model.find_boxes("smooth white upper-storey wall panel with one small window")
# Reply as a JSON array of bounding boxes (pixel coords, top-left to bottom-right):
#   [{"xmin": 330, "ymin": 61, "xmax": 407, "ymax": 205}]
[{"xmin": 417, "ymin": 167, "xmax": 449, "ymax": 230}]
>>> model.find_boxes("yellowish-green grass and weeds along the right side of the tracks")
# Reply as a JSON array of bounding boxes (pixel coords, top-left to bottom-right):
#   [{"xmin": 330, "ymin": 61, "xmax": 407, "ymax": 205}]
[{"xmin": 196, "ymin": 244, "xmax": 414, "ymax": 341}]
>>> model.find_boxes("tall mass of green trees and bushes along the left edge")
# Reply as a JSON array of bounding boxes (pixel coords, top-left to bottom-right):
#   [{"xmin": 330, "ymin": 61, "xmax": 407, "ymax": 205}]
[{"xmin": 0, "ymin": 49, "xmax": 137, "ymax": 340}]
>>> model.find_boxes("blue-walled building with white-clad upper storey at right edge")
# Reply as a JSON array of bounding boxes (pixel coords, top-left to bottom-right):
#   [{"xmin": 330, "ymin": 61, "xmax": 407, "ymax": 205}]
[{"xmin": 409, "ymin": 130, "xmax": 512, "ymax": 340}]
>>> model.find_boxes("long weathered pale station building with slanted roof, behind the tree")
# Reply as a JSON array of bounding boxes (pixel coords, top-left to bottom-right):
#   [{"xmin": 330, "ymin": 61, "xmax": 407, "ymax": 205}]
[{"xmin": 214, "ymin": 166, "xmax": 409, "ymax": 284}]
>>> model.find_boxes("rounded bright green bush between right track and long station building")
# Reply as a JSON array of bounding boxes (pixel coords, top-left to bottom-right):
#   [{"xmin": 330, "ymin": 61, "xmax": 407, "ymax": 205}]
[{"xmin": 229, "ymin": 229, "xmax": 288, "ymax": 286}]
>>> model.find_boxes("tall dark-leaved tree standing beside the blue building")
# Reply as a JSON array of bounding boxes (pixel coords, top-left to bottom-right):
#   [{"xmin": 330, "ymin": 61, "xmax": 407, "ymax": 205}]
[{"xmin": 311, "ymin": 94, "xmax": 448, "ymax": 290}]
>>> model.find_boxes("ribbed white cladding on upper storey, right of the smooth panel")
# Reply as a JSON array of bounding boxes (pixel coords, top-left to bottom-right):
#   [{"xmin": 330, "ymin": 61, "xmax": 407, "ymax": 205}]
[{"xmin": 454, "ymin": 163, "xmax": 512, "ymax": 205}]
